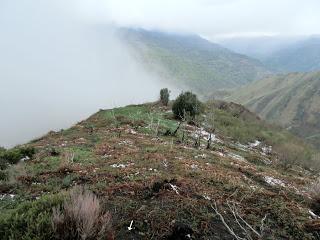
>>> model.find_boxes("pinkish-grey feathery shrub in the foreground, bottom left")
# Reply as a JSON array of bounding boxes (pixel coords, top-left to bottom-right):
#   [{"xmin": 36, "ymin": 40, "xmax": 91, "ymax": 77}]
[{"xmin": 52, "ymin": 188, "xmax": 113, "ymax": 240}]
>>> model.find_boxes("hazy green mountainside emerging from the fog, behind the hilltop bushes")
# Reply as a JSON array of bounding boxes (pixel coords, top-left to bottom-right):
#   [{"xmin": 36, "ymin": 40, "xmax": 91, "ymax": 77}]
[{"xmin": 121, "ymin": 29, "xmax": 268, "ymax": 94}]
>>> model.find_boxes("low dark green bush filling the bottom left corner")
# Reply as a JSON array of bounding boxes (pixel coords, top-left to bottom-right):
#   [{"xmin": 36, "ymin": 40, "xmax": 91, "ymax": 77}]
[{"xmin": 0, "ymin": 195, "xmax": 63, "ymax": 240}]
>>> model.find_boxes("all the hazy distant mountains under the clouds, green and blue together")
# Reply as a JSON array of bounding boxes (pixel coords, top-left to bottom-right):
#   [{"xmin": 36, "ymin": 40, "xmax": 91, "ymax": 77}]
[{"xmin": 119, "ymin": 28, "xmax": 320, "ymax": 92}]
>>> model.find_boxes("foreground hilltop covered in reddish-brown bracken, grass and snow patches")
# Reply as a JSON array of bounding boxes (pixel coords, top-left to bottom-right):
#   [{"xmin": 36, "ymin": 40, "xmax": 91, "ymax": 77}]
[{"xmin": 0, "ymin": 102, "xmax": 320, "ymax": 240}]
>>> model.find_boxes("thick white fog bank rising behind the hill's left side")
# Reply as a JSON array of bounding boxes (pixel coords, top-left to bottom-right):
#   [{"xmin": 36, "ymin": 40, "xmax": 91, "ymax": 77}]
[{"xmin": 0, "ymin": 0, "xmax": 169, "ymax": 147}]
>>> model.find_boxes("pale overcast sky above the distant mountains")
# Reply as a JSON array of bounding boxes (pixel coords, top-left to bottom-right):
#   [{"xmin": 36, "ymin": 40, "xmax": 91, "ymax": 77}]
[{"xmin": 99, "ymin": 0, "xmax": 320, "ymax": 38}]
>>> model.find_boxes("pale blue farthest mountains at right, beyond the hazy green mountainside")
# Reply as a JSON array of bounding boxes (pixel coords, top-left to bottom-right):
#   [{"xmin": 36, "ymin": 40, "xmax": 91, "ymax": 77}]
[{"xmin": 219, "ymin": 36, "xmax": 320, "ymax": 73}]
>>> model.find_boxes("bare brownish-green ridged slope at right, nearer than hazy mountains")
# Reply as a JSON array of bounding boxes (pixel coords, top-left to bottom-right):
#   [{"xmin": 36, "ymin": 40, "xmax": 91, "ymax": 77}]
[{"xmin": 226, "ymin": 72, "xmax": 320, "ymax": 146}]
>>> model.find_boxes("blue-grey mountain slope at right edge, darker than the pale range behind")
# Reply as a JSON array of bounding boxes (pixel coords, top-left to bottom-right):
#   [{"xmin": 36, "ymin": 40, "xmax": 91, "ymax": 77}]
[{"xmin": 262, "ymin": 37, "xmax": 320, "ymax": 73}]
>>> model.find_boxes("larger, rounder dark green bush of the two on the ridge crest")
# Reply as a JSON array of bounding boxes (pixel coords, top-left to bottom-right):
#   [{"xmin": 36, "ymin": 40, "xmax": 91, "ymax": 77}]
[{"xmin": 172, "ymin": 92, "xmax": 203, "ymax": 120}]
